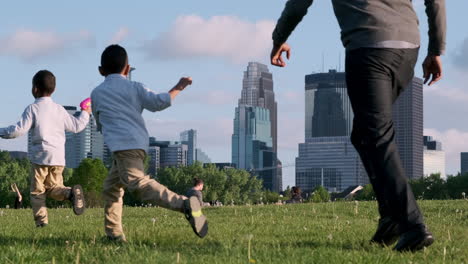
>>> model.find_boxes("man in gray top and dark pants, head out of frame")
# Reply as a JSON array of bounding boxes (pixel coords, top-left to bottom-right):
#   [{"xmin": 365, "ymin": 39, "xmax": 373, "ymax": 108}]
[{"xmin": 271, "ymin": 0, "xmax": 446, "ymax": 251}]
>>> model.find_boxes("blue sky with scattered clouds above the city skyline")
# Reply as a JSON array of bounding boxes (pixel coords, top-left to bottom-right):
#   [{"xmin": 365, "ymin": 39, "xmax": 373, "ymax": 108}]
[{"xmin": 0, "ymin": 0, "xmax": 468, "ymax": 189}]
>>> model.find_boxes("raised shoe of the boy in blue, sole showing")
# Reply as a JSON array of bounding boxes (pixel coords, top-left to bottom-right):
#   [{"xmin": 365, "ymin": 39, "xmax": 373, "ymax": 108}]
[{"xmin": 184, "ymin": 196, "xmax": 208, "ymax": 238}]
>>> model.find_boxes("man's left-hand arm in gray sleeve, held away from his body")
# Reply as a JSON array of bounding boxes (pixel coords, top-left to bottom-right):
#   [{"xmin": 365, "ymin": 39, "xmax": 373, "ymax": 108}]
[{"xmin": 270, "ymin": 0, "xmax": 313, "ymax": 67}]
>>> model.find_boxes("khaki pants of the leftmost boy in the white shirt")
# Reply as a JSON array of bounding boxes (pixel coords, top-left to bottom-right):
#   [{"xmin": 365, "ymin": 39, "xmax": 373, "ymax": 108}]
[{"xmin": 30, "ymin": 163, "xmax": 71, "ymax": 225}]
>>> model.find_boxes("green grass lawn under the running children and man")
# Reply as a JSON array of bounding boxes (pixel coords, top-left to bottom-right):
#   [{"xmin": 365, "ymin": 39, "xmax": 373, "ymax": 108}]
[{"xmin": 0, "ymin": 200, "xmax": 468, "ymax": 264}]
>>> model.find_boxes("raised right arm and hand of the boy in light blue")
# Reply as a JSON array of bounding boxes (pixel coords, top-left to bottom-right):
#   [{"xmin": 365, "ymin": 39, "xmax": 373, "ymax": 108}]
[{"xmin": 139, "ymin": 77, "xmax": 192, "ymax": 112}]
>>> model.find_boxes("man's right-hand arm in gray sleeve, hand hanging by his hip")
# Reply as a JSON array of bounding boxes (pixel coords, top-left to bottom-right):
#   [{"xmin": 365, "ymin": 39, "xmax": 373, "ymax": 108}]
[{"xmin": 422, "ymin": 0, "xmax": 447, "ymax": 85}]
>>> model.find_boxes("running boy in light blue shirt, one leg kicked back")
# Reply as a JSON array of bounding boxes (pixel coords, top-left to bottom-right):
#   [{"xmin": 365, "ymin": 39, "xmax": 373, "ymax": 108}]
[{"xmin": 91, "ymin": 45, "xmax": 208, "ymax": 242}]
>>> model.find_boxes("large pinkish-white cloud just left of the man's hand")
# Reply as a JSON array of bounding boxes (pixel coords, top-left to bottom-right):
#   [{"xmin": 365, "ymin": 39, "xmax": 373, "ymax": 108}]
[{"xmin": 144, "ymin": 15, "xmax": 275, "ymax": 63}]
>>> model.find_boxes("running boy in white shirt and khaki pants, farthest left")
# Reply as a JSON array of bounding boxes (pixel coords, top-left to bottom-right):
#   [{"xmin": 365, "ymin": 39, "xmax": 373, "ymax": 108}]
[{"xmin": 0, "ymin": 70, "xmax": 91, "ymax": 227}]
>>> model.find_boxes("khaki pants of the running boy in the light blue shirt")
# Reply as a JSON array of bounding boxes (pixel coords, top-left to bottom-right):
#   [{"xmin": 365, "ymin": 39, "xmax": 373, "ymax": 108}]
[{"xmin": 103, "ymin": 149, "xmax": 187, "ymax": 238}]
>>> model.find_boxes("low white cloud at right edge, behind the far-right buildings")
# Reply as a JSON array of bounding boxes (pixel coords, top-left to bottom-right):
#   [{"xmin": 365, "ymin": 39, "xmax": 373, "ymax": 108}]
[{"xmin": 424, "ymin": 128, "xmax": 468, "ymax": 175}]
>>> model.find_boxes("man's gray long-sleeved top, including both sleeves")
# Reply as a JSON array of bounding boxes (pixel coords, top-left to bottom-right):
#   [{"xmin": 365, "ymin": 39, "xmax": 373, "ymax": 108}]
[{"xmin": 273, "ymin": 0, "xmax": 446, "ymax": 55}]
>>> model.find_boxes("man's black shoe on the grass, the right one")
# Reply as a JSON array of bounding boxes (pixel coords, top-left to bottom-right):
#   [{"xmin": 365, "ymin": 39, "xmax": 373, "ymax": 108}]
[{"xmin": 393, "ymin": 225, "xmax": 434, "ymax": 251}]
